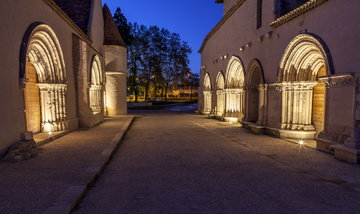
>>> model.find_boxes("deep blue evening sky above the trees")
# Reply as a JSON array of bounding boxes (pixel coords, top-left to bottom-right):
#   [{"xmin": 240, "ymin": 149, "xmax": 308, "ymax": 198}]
[{"xmin": 102, "ymin": 0, "xmax": 223, "ymax": 73}]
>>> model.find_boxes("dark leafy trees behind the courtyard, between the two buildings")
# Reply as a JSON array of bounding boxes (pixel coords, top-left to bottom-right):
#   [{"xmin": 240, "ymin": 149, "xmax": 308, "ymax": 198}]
[{"xmin": 114, "ymin": 8, "xmax": 198, "ymax": 102}]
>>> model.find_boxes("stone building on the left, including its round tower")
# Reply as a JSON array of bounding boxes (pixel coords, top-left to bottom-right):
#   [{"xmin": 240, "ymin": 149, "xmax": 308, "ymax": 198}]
[{"xmin": 0, "ymin": 0, "xmax": 127, "ymax": 158}]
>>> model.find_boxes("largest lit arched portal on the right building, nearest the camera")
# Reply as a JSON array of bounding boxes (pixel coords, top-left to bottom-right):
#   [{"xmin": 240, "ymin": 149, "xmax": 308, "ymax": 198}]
[{"xmin": 278, "ymin": 34, "xmax": 333, "ymax": 138}]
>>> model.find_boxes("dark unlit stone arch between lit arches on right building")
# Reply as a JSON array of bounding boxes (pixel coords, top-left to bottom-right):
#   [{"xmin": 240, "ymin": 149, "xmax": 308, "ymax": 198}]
[{"xmin": 245, "ymin": 59, "xmax": 265, "ymax": 123}]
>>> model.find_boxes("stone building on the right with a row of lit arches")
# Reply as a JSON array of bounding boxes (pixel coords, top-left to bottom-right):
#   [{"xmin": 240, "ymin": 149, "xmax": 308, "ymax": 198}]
[{"xmin": 198, "ymin": 0, "xmax": 360, "ymax": 163}]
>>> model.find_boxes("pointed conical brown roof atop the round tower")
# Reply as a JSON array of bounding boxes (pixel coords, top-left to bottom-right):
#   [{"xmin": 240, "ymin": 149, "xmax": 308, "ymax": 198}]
[{"xmin": 103, "ymin": 4, "xmax": 126, "ymax": 47}]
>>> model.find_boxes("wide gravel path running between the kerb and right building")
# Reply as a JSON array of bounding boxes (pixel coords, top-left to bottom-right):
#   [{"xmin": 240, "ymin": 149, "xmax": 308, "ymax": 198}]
[{"xmin": 74, "ymin": 110, "xmax": 360, "ymax": 213}]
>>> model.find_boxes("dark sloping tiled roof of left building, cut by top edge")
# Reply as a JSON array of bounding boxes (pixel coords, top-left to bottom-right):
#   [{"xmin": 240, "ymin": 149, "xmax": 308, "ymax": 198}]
[{"xmin": 54, "ymin": 0, "xmax": 91, "ymax": 33}]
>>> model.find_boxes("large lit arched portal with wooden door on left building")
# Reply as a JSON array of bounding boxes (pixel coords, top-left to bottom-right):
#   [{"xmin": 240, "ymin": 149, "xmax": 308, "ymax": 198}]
[{"xmin": 20, "ymin": 23, "xmax": 68, "ymax": 133}]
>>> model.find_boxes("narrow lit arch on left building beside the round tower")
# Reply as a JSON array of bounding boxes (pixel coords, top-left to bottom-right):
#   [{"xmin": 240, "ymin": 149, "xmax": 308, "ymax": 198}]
[{"xmin": 89, "ymin": 55, "xmax": 103, "ymax": 113}]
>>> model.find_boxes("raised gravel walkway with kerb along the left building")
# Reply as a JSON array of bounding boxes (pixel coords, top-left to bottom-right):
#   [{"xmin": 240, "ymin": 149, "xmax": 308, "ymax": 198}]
[{"xmin": 0, "ymin": 116, "xmax": 132, "ymax": 214}]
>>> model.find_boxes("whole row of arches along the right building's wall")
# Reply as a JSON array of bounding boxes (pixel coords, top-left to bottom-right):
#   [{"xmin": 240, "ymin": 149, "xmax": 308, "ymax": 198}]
[{"xmin": 203, "ymin": 34, "xmax": 330, "ymax": 139}]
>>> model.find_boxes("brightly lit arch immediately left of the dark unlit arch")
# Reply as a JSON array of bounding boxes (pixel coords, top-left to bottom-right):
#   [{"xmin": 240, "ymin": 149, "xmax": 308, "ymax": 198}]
[{"xmin": 225, "ymin": 56, "xmax": 245, "ymax": 120}]
